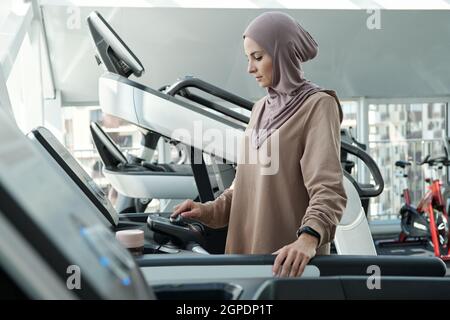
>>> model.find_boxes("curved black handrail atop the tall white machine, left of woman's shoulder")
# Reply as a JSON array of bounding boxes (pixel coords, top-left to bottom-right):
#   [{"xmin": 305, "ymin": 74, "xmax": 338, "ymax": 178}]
[{"xmin": 165, "ymin": 77, "xmax": 254, "ymax": 111}]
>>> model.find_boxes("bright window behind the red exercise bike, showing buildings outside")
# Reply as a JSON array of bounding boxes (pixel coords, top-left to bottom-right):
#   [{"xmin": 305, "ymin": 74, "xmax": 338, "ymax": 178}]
[{"xmin": 368, "ymin": 103, "xmax": 447, "ymax": 220}]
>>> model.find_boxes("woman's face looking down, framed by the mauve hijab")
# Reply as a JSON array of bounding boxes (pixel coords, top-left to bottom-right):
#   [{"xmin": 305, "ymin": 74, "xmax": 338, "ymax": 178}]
[{"xmin": 244, "ymin": 37, "xmax": 272, "ymax": 88}]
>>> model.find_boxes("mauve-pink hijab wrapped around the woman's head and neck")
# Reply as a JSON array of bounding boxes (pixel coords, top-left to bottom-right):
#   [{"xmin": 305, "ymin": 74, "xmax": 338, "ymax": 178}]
[{"xmin": 243, "ymin": 12, "xmax": 343, "ymax": 149}]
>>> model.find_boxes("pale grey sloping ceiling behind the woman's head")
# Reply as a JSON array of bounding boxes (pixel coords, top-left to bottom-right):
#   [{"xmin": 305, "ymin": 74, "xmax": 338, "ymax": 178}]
[{"xmin": 42, "ymin": 5, "xmax": 450, "ymax": 105}]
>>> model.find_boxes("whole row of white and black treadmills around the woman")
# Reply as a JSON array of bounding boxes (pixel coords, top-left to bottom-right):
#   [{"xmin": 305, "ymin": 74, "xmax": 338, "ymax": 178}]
[{"xmin": 0, "ymin": 12, "xmax": 450, "ymax": 300}]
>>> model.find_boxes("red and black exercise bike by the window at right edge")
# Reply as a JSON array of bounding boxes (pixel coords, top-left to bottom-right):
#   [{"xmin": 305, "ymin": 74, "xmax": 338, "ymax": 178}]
[{"xmin": 395, "ymin": 155, "xmax": 450, "ymax": 260}]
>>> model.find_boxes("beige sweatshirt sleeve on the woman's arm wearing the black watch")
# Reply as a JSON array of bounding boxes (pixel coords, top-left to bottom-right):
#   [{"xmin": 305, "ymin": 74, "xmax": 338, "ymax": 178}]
[{"xmin": 300, "ymin": 95, "xmax": 347, "ymax": 247}]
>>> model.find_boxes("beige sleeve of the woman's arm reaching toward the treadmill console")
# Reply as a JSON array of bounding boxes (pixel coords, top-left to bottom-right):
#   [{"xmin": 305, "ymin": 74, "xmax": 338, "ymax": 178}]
[{"xmin": 202, "ymin": 181, "xmax": 234, "ymax": 229}]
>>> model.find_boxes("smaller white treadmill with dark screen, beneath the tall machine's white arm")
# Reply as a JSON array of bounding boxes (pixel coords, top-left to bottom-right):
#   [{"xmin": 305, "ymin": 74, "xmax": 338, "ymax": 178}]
[{"xmin": 90, "ymin": 122, "xmax": 235, "ymax": 202}]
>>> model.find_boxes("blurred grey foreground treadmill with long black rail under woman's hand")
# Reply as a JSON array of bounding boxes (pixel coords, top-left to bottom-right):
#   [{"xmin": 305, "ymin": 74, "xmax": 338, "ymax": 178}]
[{"xmin": 0, "ymin": 110, "xmax": 450, "ymax": 300}]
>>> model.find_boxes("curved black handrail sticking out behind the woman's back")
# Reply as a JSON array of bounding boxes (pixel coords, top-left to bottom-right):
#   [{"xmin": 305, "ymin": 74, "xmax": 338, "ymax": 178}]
[{"xmin": 341, "ymin": 140, "xmax": 384, "ymax": 197}]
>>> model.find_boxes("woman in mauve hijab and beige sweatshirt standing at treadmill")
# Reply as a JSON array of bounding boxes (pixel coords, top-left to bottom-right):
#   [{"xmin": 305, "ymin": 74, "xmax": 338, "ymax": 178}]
[{"xmin": 172, "ymin": 12, "xmax": 347, "ymax": 276}]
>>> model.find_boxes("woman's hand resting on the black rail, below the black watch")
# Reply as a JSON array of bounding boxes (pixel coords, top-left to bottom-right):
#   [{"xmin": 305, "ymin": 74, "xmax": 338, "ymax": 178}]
[{"xmin": 272, "ymin": 233, "xmax": 319, "ymax": 277}]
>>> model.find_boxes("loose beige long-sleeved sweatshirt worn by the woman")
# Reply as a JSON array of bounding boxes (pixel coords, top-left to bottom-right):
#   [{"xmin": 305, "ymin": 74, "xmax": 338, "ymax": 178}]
[{"xmin": 204, "ymin": 92, "xmax": 347, "ymax": 254}]
